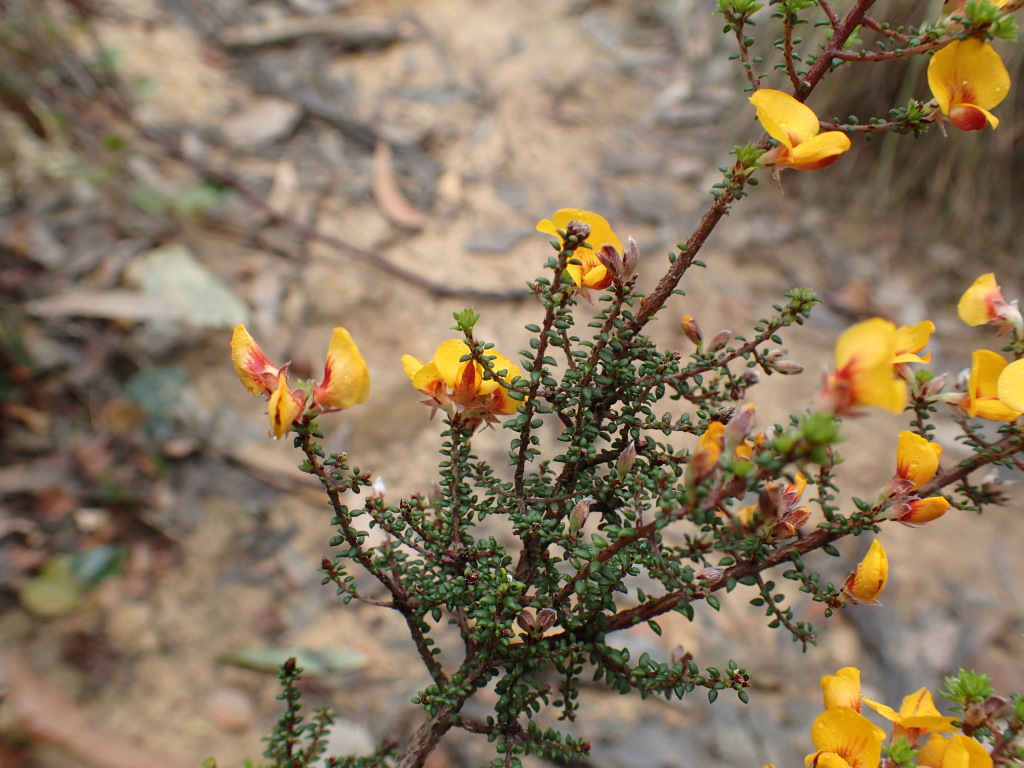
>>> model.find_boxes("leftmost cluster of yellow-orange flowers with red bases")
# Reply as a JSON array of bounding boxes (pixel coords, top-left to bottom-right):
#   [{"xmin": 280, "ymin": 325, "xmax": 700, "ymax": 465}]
[{"xmin": 231, "ymin": 324, "xmax": 370, "ymax": 439}]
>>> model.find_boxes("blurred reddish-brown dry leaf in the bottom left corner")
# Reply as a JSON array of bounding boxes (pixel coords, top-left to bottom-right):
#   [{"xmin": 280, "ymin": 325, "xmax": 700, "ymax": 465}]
[{"xmin": 5, "ymin": 652, "xmax": 193, "ymax": 768}]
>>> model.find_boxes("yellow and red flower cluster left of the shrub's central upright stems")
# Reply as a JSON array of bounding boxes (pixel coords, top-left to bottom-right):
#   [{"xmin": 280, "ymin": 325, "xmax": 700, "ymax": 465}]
[{"xmin": 401, "ymin": 339, "xmax": 521, "ymax": 422}]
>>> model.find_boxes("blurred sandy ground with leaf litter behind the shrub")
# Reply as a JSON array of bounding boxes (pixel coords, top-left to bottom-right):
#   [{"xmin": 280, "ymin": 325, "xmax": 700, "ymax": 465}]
[{"xmin": 0, "ymin": 0, "xmax": 1024, "ymax": 768}]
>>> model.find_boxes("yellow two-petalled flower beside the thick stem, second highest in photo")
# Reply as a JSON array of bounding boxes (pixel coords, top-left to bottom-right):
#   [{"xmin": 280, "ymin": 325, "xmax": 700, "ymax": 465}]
[{"xmin": 751, "ymin": 88, "xmax": 850, "ymax": 171}]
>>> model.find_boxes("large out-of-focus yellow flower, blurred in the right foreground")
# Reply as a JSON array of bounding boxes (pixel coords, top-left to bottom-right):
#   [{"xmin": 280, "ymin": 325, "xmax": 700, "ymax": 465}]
[{"xmin": 816, "ymin": 317, "xmax": 906, "ymax": 416}]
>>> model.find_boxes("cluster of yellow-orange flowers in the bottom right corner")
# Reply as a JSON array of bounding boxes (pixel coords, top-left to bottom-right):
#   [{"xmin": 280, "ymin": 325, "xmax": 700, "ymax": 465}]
[{"xmin": 804, "ymin": 667, "xmax": 992, "ymax": 768}]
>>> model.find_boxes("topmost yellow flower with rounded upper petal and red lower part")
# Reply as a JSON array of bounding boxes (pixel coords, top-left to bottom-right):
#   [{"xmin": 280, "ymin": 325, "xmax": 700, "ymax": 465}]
[{"xmin": 928, "ymin": 39, "xmax": 1010, "ymax": 131}]
